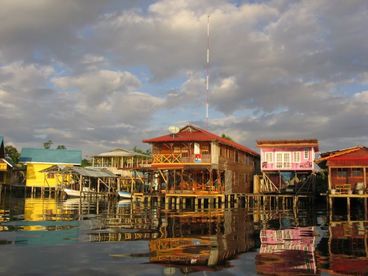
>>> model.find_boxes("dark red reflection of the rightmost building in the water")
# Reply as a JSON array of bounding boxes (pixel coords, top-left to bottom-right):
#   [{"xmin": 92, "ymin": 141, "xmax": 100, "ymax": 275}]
[{"xmin": 328, "ymin": 221, "xmax": 368, "ymax": 275}]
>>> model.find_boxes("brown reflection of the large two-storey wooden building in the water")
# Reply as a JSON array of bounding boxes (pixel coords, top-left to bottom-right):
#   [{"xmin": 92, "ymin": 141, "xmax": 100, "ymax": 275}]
[{"xmin": 150, "ymin": 210, "xmax": 254, "ymax": 266}]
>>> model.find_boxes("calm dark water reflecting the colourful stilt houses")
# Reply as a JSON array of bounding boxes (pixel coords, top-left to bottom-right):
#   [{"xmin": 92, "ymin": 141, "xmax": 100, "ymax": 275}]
[{"xmin": 0, "ymin": 195, "xmax": 368, "ymax": 275}]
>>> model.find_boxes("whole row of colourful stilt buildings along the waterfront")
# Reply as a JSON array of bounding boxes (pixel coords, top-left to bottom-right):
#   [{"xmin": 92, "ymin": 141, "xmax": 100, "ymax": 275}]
[{"xmin": 0, "ymin": 124, "xmax": 368, "ymax": 218}]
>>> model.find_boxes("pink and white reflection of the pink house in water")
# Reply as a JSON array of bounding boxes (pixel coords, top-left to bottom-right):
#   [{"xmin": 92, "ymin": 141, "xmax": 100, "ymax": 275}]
[{"xmin": 256, "ymin": 227, "xmax": 317, "ymax": 275}]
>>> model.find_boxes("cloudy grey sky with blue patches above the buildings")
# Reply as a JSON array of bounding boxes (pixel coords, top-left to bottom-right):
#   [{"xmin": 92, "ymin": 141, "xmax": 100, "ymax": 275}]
[{"xmin": 0, "ymin": 0, "xmax": 368, "ymax": 156}]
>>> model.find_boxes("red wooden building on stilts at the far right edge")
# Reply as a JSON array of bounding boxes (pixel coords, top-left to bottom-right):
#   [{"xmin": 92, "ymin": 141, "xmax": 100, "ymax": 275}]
[{"xmin": 316, "ymin": 146, "xmax": 368, "ymax": 195}]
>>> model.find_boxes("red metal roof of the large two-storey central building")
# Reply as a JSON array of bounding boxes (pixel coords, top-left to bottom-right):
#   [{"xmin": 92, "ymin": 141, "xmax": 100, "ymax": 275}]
[{"xmin": 143, "ymin": 125, "xmax": 259, "ymax": 156}]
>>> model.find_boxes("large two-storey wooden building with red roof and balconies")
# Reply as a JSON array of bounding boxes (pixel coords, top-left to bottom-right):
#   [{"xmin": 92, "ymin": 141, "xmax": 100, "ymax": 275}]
[{"xmin": 143, "ymin": 125, "xmax": 259, "ymax": 201}]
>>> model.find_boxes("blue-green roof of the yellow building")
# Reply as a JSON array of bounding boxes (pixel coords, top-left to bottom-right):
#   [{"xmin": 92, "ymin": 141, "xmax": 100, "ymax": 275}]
[{"xmin": 20, "ymin": 148, "xmax": 82, "ymax": 165}]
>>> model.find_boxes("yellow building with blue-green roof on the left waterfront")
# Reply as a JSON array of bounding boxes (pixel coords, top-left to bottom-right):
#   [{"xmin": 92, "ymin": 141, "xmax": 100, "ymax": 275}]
[{"xmin": 20, "ymin": 148, "xmax": 82, "ymax": 188}]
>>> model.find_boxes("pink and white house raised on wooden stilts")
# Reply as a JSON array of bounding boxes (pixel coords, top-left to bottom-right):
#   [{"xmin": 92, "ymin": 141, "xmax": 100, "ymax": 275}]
[{"xmin": 255, "ymin": 139, "xmax": 319, "ymax": 194}]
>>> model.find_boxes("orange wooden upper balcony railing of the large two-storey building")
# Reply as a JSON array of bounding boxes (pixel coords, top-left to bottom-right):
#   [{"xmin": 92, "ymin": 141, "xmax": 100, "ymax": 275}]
[{"xmin": 152, "ymin": 153, "xmax": 211, "ymax": 164}]
